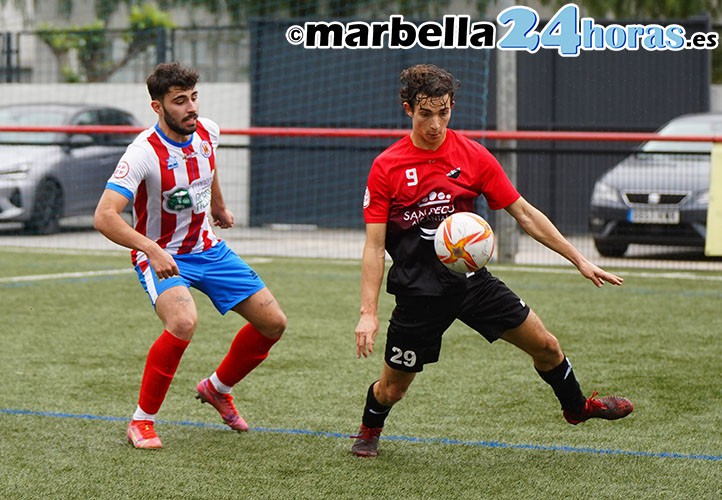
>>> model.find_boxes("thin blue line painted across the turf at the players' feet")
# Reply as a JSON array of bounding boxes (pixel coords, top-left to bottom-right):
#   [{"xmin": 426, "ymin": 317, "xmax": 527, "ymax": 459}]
[{"xmin": 0, "ymin": 408, "xmax": 722, "ymax": 462}]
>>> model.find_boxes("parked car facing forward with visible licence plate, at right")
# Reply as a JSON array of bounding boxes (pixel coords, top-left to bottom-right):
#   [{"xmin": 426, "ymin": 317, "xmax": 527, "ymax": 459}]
[{"xmin": 589, "ymin": 113, "xmax": 722, "ymax": 257}]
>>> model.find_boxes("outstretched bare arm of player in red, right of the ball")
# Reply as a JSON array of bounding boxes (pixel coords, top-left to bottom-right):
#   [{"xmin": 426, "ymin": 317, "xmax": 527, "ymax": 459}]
[{"xmin": 506, "ymin": 196, "xmax": 624, "ymax": 287}]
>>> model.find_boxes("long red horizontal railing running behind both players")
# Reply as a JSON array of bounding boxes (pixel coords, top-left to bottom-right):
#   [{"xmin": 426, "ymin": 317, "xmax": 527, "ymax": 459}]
[{"xmin": 0, "ymin": 125, "xmax": 722, "ymax": 143}]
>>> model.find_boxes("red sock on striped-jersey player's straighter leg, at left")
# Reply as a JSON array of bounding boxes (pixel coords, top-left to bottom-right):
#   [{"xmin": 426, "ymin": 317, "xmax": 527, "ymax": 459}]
[{"xmin": 138, "ymin": 330, "xmax": 190, "ymax": 415}]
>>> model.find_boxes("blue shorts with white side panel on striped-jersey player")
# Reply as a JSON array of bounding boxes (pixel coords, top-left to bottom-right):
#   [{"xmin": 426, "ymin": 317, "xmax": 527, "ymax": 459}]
[{"xmin": 135, "ymin": 241, "xmax": 266, "ymax": 314}]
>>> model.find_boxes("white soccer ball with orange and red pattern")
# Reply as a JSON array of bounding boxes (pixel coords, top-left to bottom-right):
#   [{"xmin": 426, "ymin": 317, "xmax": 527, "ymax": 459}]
[{"xmin": 434, "ymin": 212, "xmax": 494, "ymax": 273}]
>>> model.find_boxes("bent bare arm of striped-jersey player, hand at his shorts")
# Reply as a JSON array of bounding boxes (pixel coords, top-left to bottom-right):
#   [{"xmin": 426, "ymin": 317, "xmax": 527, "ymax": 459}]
[{"xmin": 93, "ymin": 189, "xmax": 179, "ymax": 279}]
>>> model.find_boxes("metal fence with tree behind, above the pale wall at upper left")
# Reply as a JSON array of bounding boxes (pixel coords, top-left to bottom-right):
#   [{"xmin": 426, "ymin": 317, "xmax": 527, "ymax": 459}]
[{"xmin": 0, "ymin": 27, "xmax": 249, "ymax": 83}]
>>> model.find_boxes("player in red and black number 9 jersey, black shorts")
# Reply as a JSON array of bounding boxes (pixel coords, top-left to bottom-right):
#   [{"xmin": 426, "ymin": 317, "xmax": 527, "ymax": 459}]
[{"xmin": 351, "ymin": 65, "xmax": 633, "ymax": 457}]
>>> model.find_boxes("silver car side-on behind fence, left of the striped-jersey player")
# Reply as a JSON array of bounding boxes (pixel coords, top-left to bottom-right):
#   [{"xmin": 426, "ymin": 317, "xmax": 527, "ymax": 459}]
[{"xmin": 0, "ymin": 103, "xmax": 140, "ymax": 234}]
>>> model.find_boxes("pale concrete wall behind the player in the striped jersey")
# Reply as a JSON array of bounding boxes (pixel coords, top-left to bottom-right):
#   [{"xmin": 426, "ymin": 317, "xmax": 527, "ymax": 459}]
[{"xmin": 0, "ymin": 83, "xmax": 250, "ymax": 226}]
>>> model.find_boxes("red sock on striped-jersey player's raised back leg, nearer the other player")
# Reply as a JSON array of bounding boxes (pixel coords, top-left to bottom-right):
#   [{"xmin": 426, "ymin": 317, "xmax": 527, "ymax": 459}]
[{"xmin": 216, "ymin": 323, "xmax": 278, "ymax": 387}]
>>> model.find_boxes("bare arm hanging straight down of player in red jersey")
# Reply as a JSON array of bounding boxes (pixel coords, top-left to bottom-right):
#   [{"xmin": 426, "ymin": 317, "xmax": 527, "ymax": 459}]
[{"xmin": 356, "ymin": 223, "xmax": 386, "ymax": 358}]
